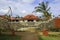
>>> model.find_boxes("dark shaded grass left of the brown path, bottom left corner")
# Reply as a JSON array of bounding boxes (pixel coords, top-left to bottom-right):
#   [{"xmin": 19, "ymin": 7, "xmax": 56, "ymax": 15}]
[{"xmin": 0, "ymin": 34, "xmax": 21, "ymax": 40}]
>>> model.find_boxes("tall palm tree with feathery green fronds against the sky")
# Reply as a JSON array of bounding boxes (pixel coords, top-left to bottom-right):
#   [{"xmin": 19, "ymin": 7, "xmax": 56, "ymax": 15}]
[{"xmin": 35, "ymin": 2, "xmax": 51, "ymax": 18}]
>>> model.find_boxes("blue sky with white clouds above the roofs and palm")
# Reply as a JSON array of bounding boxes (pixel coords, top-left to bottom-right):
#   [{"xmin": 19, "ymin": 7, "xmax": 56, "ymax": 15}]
[{"xmin": 0, "ymin": 0, "xmax": 60, "ymax": 16}]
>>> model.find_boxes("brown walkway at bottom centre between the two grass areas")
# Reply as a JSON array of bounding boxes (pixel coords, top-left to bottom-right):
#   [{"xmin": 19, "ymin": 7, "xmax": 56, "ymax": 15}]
[{"xmin": 21, "ymin": 32, "xmax": 38, "ymax": 40}]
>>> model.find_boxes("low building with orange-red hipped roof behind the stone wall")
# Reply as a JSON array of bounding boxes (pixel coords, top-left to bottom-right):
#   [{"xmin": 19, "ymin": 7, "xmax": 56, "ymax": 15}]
[{"xmin": 9, "ymin": 14, "xmax": 42, "ymax": 22}]
